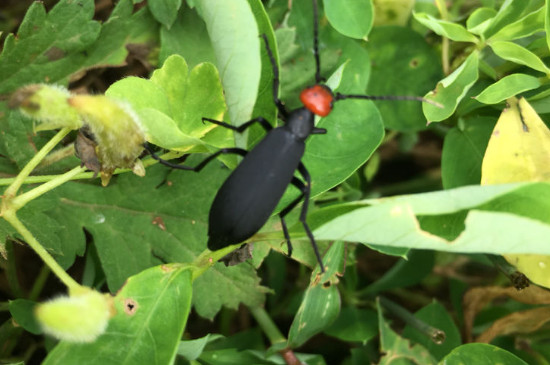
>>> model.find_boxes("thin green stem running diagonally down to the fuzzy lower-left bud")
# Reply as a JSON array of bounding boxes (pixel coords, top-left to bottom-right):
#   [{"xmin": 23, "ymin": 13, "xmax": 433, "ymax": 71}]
[{"xmin": 4, "ymin": 209, "xmax": 80, "ymax": 291}]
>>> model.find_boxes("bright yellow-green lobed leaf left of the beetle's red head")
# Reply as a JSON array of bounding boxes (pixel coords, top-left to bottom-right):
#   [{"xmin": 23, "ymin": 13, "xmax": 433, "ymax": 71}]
[{"xmin": 105, "ymin": 55, "xmax": 225, "ymax": 151}]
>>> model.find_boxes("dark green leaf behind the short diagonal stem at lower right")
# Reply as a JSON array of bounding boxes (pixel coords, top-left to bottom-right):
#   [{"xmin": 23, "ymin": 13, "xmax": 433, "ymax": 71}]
[{"xmin": 403, "ymin": 300, "xmax": 462, "ymax": 360}]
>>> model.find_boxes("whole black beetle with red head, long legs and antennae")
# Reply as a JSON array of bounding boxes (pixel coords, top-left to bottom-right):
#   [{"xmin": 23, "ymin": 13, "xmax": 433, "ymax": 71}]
[{"xmin": 146, "ymin": 0, "xmax": 440, "ymax": 272}]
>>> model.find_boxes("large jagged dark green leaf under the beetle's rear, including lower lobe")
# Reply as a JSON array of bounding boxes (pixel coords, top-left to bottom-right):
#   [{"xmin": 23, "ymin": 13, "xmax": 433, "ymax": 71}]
[{"xmin": 44, "ymin": 163, "xmax": 266, "ymax": 318}]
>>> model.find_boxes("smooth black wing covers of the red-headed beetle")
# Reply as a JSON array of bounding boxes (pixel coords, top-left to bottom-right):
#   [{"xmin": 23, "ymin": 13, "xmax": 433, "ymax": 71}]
[{"xmin": 208, "ymin": 128, "xmax": 305, "ymax": 250}]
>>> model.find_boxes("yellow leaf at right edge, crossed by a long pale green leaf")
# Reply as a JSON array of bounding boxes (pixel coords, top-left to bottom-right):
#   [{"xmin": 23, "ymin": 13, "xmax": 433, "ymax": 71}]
[{"xmin": 481, "ymin": 98, "xmax": 550, "ymax": 288}]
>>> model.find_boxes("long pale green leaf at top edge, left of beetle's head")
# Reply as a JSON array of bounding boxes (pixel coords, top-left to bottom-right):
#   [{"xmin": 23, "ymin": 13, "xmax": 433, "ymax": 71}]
[{"xmin": 196, "ymin": 0, "xmax": 262, "ymax": 144}]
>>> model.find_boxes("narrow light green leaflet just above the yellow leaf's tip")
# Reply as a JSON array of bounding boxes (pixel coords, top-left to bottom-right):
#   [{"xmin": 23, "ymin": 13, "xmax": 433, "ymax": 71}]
[{"xmin": 475, "ymin": 74, "xmax": 541, "ymax": 104}]
